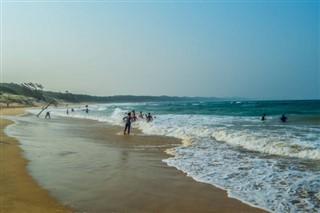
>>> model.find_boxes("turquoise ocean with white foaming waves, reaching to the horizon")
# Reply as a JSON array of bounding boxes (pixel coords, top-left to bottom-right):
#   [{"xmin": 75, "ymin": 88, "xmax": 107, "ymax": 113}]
[{"xmin": 8, "ymin": 100, "xmax": 320, "ymax": 212}]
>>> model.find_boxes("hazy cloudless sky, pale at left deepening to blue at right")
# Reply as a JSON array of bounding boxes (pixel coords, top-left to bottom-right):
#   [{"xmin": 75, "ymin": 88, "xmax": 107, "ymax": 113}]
[{"xmin": 0, "ymin": 0, "xmax": 320, "ymax": 100}]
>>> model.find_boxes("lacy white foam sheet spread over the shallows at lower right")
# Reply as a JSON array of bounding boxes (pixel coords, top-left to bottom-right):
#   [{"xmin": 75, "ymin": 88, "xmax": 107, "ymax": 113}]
[{"xmin": 164, "ymin": 140, "xmax": 320, "ymax": 212}]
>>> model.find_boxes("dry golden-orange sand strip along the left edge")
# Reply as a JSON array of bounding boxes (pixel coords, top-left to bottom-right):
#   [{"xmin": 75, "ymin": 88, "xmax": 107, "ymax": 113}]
[{"xmin": 0, "ymin": 108, "xmax": 74, "ymax": 213}]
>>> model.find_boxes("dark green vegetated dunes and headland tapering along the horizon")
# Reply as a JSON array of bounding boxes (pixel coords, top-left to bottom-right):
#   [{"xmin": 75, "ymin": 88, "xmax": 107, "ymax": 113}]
[{"xmin": 0, "ymin": 82, "xmax": 222, "ymax": 106}]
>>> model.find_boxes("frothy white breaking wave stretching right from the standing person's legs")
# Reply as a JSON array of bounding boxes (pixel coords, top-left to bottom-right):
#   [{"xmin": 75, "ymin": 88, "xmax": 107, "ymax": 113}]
[{"xmin": 133, "ymin": 115, "xmax": 320, "ymax": 160}]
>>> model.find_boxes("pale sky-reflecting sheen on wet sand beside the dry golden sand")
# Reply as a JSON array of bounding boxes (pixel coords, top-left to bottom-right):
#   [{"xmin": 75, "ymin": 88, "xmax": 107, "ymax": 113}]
[{"xmin": 6, "ymin": 115, "xmax": 124, "ymax": 210}]
